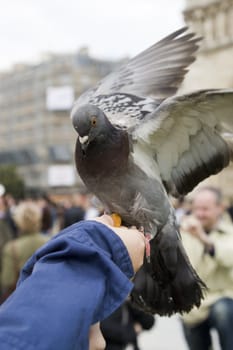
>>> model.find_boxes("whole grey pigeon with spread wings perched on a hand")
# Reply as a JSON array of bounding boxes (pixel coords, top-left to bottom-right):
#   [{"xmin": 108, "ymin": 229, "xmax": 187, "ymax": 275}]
[{"xmin": 71, "ymin": 27, "xmax": 233, "ymax": 315}]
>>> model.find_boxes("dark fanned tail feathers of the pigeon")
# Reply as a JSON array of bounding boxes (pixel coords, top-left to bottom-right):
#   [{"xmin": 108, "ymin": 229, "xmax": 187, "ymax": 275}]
[{"xmin": 131, "ymin": 225, "xmax": 206, "ymax": 316}]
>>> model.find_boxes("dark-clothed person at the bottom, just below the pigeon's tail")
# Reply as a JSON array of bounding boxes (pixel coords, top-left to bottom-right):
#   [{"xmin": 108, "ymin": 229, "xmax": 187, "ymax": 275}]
[{"xmin": 101, "ymin": 301, "xmax": 155, "ymax": 350}]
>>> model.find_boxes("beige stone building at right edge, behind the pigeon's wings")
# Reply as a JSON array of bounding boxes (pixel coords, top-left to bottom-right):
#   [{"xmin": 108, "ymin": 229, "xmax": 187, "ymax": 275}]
[{"xmin": 180, "ymin": 0, "xmax": 233, "ymax": 198}]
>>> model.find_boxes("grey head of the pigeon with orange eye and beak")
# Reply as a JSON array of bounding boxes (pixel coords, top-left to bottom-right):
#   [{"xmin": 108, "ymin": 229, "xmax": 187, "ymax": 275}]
[{"xmin": 71, "ymin": 104, "xmax": 111, "ymax": 151}]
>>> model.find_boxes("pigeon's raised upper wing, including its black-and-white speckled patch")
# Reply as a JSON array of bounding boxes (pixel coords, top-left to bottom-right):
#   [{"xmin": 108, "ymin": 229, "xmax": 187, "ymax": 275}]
[{"xmin": 76, "ymin": 27, "xmax": 200, "ymax": 128}]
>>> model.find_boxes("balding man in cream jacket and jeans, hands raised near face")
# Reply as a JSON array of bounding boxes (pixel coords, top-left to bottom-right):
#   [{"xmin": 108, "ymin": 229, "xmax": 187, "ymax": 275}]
[{"xmin": 181, "ymin": 187, "xmax": 233, "ymax": 350}]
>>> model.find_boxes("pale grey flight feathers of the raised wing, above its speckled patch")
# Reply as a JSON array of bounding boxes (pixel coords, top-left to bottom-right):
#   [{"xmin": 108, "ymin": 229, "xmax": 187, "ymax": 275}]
[{"xmin": 77, "ymin": 27, "xmax": 200, "ymax": 104}]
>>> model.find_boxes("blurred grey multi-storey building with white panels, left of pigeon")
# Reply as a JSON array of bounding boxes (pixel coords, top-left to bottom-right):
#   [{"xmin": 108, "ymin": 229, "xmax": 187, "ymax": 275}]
[{"xmin": 0, "ymin": 49, "xmax": 124, "ymax": 190}]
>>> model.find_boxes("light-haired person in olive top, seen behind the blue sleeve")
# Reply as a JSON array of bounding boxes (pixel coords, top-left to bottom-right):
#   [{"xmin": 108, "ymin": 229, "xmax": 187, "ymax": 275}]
[{"xmin": 1, "ymin": 202, "xmax": 48, "ymax": 301}]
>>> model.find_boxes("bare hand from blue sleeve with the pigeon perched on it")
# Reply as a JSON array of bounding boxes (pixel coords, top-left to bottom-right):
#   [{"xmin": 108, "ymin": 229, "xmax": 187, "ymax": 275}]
[{"xmin": 94, "ymin": 214, "xmax": 146, "ymax": 272}]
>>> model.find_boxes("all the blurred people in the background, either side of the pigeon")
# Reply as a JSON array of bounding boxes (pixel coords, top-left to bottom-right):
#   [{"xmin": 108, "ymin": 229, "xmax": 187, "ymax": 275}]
[{"xmin": 0, "ymin": 187, "xmax": 233, "ymax": 350}]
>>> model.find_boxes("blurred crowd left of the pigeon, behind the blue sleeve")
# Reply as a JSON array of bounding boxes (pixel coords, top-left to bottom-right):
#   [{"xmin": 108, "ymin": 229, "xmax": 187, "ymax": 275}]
[{"xmin": 0, "ymin": 190, "xmax": 102, "ymax": 301}]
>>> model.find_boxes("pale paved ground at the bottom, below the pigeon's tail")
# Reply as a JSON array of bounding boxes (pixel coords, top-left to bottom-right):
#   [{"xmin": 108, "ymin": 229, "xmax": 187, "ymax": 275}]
[{"xmin": 135, "ymin": 316, "xmax": 220, "ymax": 350}]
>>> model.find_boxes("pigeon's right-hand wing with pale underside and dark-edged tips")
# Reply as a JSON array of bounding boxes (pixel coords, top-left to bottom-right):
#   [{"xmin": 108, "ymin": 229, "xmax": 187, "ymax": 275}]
[{"xmin": 133, "ymin": 90, "xmax": 233, "ymax": 195}]
